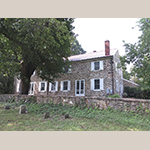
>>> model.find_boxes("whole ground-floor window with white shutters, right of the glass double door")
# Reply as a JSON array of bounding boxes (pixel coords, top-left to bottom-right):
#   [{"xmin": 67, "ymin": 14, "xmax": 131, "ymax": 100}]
[{"xmin": 91, "ymin": 78, "xmax": 104, "ymax": 91}]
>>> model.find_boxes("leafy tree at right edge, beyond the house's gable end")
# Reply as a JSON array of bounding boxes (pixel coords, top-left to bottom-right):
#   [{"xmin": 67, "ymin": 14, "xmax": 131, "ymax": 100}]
[{"xmin": 123, "ymin": 18, "xmax": 150, "ymax": 89}]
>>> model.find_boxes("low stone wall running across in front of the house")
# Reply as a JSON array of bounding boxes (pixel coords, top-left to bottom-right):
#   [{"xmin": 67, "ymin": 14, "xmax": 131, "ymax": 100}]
[{"xmin": 0, "ymin": 94, "xmax": 150, "ymax": 111}]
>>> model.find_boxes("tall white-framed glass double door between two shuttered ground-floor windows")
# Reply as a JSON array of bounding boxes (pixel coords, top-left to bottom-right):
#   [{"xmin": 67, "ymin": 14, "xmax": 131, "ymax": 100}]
[{"xmin": 75, "ymin": 80, "xmax": 85, "ymax": 96}]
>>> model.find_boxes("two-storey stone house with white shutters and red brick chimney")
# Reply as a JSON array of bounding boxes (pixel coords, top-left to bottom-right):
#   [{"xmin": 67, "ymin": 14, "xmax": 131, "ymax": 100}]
[{"xmin": 16, "ymin": 40, "xmax": 123, "ymax": 97}]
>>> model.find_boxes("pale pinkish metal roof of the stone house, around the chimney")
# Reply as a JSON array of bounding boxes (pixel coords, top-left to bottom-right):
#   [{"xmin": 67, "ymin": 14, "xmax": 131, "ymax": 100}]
[{"xmin": 68, "ymin": 49, "xmax": 117, "ymax": 61}]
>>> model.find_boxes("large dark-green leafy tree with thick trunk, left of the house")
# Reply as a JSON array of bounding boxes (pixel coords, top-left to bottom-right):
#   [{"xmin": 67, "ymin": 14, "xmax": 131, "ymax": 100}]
[{"xmin": 0, "ymin": 18, "xmax": 74, "ymax": 94}]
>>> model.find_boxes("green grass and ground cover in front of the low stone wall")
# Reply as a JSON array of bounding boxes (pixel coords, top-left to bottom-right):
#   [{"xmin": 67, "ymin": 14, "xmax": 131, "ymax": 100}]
[{"xmin": 0, "ymin": 103, "xmax": 150, "ymax": 131}]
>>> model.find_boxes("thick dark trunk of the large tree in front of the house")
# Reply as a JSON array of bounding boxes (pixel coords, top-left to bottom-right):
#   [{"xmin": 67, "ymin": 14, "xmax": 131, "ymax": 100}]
[{"xmin": 20, "ymin": 62, "xmax": 35, "ymax": 94}]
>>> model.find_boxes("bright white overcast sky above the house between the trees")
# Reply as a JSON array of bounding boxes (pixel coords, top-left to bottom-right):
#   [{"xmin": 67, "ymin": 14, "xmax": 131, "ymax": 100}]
[{"xmin": 73, "ymin": 18, "xmax": 141, "ymax": 56}]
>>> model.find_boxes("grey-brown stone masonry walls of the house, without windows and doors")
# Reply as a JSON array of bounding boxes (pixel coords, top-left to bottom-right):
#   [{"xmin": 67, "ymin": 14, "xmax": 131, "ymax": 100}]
[{"xmin": 31, "ymin": 57, "xmax": 118, "ymax": 97}]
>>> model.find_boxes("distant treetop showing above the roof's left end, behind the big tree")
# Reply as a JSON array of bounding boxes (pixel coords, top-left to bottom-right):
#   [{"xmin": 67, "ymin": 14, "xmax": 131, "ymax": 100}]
[{"xmin": 71, "ymin": 37, "xmax": 86, "ymax": 55}]
